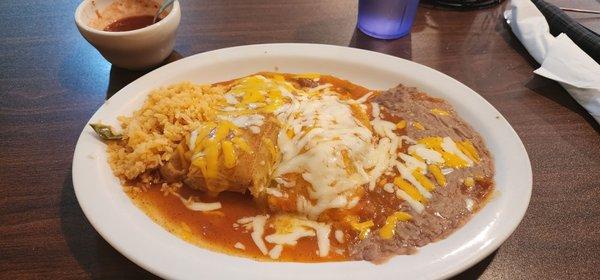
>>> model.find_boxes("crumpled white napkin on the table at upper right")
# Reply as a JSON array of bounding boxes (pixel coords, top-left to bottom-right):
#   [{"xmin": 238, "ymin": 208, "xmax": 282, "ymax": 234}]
[{"xmin": 504, "ymin": 0, "xmax": 600, "ymax": 123}]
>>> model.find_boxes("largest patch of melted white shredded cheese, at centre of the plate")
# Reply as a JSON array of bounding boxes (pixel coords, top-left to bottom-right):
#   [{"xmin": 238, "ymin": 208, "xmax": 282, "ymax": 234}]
[{"xmin": 274, "ymin": 94, "xmax": 373, "ymax": 219}]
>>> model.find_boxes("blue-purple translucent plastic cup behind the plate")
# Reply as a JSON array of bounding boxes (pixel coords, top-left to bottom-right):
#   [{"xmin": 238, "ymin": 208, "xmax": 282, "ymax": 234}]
[{"xmin": 358, "ymin": 0, "xmax": 419, "ymax": 39}]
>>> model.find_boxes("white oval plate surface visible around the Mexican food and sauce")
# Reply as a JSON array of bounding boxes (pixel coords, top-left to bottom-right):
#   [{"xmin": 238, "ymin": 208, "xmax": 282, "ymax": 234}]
[{"xmin": 73, "ymin": 44, "xmax": 532, "ymax": 280}]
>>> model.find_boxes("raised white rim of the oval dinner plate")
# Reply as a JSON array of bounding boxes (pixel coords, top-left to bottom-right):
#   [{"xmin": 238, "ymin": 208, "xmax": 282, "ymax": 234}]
[{"xmin": 72, "ymin": 43, "xmax": 532, "ymax": 279}]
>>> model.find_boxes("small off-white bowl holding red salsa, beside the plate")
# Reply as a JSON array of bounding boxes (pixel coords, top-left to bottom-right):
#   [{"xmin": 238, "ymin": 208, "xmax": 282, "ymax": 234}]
[{"xmin": 75, "ymin": 0, "xmax": 181, "ymax": 70}]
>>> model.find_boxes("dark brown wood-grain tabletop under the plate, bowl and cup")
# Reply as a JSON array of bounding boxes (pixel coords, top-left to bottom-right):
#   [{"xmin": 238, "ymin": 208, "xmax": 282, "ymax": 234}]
[{"xmin": 0, "ymin": 0, "xmax": 600, "ymax": 279}]
